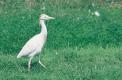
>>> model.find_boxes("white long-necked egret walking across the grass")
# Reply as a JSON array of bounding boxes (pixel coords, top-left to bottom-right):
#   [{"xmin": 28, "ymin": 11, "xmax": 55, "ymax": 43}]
[{"xmin": 17, "ymin": 14, "xmax": 55, "ymax": 71}]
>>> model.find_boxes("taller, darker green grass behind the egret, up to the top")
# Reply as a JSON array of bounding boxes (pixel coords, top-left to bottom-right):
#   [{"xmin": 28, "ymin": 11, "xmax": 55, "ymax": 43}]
[{"xmin": 0, "ymin": 0, "xmax": 122, "ymax": 53}]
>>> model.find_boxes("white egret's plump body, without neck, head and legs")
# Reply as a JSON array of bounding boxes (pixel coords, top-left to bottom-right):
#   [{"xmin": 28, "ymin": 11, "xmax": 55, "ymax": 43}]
[{"xmin": 17, "ymin": 33, "xmax": 47, "ymax": 58}]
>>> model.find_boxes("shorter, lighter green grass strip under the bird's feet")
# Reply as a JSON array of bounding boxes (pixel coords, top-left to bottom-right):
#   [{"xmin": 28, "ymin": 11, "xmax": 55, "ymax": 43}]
[{"xmin": 0, "ymin": 47, "xmax": 122, "ymax": 80}]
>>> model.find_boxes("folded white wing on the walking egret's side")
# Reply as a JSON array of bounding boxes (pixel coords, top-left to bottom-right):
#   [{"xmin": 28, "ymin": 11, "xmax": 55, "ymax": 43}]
[{"xmin": 18, "ymin": 34, "xmax": 39, "ymax": 57}]
